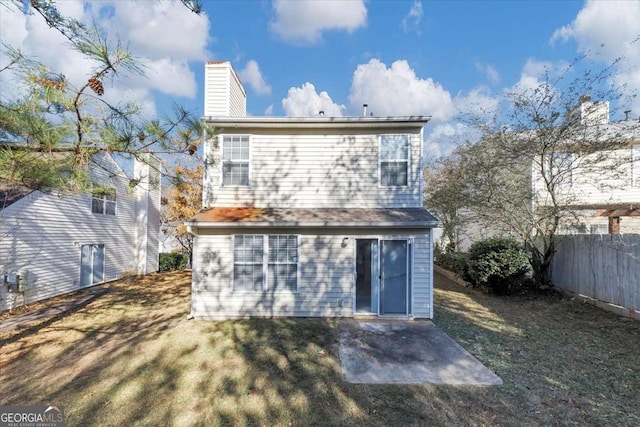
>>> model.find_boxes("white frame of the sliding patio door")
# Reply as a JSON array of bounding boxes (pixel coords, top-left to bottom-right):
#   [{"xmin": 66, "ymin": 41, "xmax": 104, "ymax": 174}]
[{"xmin": 350, "ymin": 234, "xmax": 415, "ymax": 317}]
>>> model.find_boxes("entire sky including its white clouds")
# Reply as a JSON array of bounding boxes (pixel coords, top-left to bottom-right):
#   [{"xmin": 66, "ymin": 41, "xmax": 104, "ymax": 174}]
[{"xmin": 0, "ymin": 0, "xmax": 640, "ymax": 156}]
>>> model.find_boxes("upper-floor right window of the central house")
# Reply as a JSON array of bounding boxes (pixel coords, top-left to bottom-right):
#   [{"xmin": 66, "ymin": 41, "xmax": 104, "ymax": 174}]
[{"xmin": 380, "ymin": 135, "xmax": 409, "ymax": 187}]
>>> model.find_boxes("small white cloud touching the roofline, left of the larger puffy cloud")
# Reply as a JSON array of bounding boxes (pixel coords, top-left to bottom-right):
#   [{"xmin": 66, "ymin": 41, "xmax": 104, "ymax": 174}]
[{"xmin": 282, "ymin": 82, "xmax": 345, "ymax": 117}]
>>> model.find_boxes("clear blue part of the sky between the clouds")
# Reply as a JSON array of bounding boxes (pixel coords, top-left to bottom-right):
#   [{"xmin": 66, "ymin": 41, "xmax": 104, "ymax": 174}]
[{"xmin": 205, "ymin": 1, "xmax": 583, "ymax": 115}]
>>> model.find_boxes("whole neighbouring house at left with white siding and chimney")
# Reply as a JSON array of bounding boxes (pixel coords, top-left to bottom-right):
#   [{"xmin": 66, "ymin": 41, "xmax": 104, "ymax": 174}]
[{"xmin": 0, "ymin": 155, "xmax": 160, "ymax": 310}]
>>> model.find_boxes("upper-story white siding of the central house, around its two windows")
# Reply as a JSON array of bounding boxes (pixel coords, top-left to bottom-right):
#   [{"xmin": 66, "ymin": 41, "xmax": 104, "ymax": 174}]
[{"xmin": 204, "ymin": 129, "xmax": 422, "ymax": 208}]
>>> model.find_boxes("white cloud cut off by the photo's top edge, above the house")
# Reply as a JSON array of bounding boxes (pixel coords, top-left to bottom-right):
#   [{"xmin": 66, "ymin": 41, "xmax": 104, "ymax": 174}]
[{"xmin": 270, "ymin": 0, "xmax": 367, "ymax": 44}]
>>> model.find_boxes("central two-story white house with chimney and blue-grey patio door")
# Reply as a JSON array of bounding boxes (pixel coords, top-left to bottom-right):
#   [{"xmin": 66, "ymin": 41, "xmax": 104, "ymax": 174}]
[{"xmin": 188, "ymin": 63, "xmax": 438, "ymax": 319}]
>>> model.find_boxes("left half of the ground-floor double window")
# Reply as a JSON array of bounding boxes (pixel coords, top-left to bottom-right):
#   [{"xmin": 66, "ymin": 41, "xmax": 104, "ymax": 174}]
[{"xmin": 233, "ymin": 235, "xmax": 264, "ymax": 291}]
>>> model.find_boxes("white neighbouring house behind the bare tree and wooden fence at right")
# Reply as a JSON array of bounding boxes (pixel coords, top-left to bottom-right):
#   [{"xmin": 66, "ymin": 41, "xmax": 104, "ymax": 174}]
[{"xmin": 532, "ymin": 100, "xmax": 640, "ymax": 234}]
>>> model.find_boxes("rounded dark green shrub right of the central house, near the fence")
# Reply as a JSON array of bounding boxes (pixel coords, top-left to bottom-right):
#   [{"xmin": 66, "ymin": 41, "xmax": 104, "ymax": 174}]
[{"xmin": 467, "ymin": 237, "xmax": 530, "ymax": 294}]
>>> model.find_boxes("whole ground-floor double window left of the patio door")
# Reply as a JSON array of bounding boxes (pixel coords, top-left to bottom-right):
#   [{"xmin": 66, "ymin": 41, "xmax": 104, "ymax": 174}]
[{"xmin": 233, "ymin": 234, "xmax": 299, "ymax": 292}]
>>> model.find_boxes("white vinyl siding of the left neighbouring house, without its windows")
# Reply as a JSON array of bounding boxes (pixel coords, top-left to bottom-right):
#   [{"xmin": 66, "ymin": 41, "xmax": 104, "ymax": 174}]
[{"xmin": 0, "ymin": 154, "xmax": 160, "ymax": 311}]
